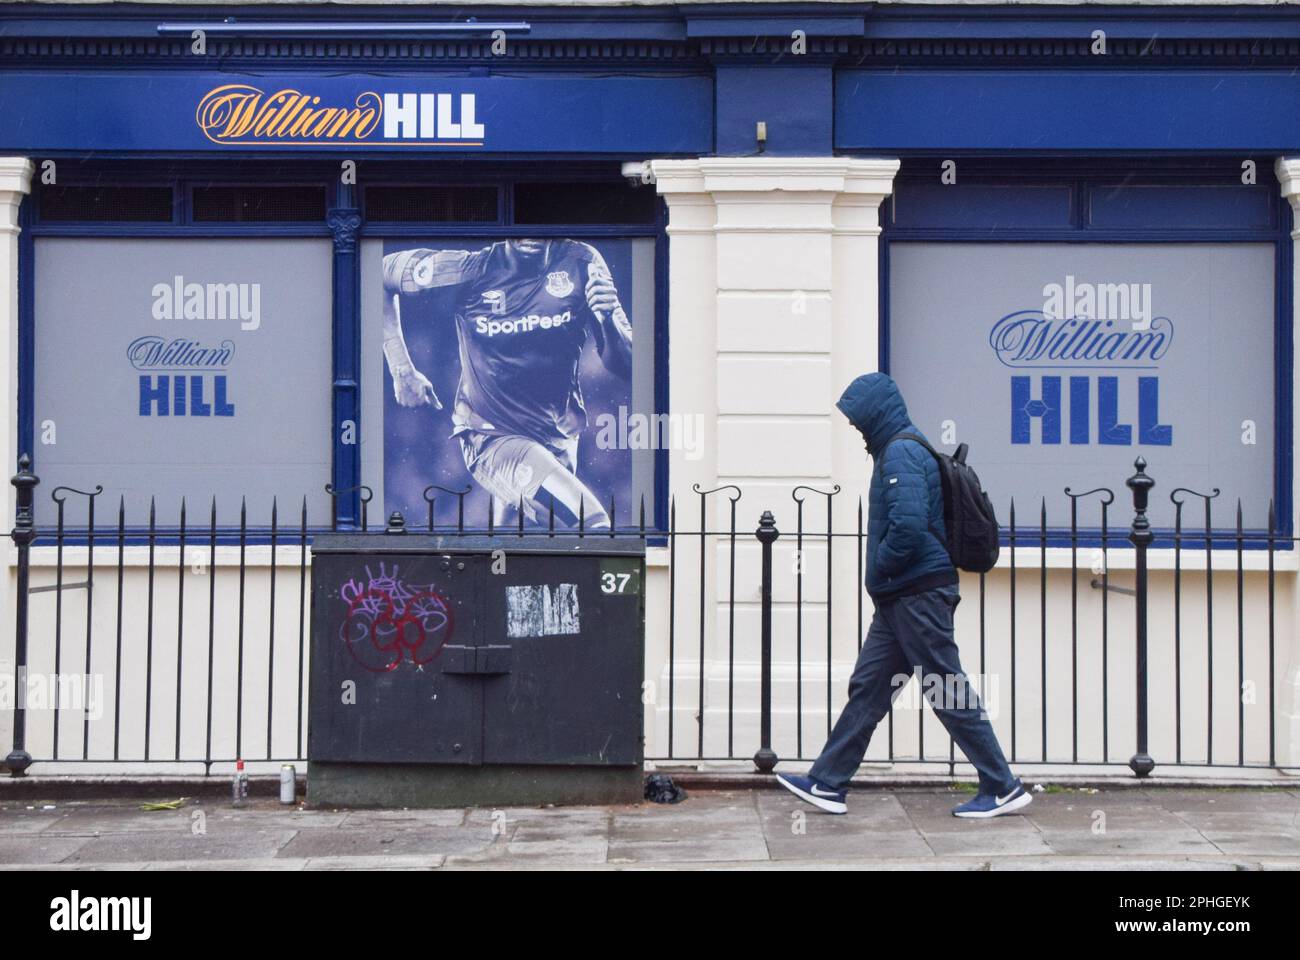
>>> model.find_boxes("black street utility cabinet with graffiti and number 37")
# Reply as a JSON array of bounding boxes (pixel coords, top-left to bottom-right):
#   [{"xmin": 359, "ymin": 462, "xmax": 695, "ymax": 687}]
[{"xmin": 307, "ymin": 532, "xmax": 645, "ymax": 807}]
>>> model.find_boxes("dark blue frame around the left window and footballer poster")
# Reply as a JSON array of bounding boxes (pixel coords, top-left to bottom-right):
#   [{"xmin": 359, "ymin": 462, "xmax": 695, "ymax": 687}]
[{"xmin": 17, "ymin": 159, "xmax": 668, "ymax": 542}]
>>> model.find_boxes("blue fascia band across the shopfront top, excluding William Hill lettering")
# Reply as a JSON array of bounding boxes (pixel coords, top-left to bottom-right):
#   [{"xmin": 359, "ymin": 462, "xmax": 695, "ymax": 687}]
[{"xmin": 0, "ymin": 4, "xmax": 1300, "ymax": 156}]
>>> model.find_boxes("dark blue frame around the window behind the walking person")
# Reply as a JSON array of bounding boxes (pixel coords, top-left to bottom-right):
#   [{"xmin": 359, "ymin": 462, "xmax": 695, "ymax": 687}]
[{"xmin": 879, "ymin": 153, "xmax": 1295, "ymax": 549}]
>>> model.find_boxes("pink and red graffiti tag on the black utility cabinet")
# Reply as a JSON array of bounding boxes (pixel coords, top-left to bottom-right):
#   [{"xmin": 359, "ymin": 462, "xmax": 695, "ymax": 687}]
[{"xmin": 338, "ymin": 563, "xmax": 455, "ymax": 673}]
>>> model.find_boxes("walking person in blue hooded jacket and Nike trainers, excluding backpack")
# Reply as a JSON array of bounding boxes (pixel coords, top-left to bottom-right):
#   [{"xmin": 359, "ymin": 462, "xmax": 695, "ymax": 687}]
[{"xmin": 776, "ymin": 373, "xmax": 1034, "ymax": 818}]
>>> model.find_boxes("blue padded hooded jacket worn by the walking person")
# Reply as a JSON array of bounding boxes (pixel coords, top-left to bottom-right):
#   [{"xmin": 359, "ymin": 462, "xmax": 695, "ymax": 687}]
[{"xmin": 835, "ymin": 373, "xmax": 957, "ymax": 600}]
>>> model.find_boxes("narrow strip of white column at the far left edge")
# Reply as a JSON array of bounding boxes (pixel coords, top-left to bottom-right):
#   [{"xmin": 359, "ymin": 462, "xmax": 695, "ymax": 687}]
[{"xmin": 0, "ymin": 156, "xmax": 33, "ymax": 757}]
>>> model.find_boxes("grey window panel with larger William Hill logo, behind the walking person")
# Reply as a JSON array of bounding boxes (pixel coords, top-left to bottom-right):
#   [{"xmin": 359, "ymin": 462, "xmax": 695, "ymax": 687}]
[{"xmin": 889, "ymin": 242, "xmax": 1275, "ymax": 528}]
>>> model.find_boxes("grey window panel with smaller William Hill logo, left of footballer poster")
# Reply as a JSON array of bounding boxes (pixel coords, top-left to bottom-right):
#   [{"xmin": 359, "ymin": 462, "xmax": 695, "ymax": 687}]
[{"xmin": 33, "ymin": 237, "xmax": 333, "ymax": 527}]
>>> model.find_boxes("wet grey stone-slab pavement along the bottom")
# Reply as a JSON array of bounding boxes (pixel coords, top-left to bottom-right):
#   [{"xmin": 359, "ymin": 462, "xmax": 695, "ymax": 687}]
[{"xmin": 0, "ymin": 787, "xmax": 1300, "ymax": 870}]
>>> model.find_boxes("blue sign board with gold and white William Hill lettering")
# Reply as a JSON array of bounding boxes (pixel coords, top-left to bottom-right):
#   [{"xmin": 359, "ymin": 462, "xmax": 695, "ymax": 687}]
[{"xmin": 0, "ymin": 70, "xmax": 714, "ymax": 156}]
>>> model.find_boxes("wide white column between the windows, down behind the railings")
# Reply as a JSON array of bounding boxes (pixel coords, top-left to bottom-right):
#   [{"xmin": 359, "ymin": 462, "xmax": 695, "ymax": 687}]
[{"xmin": 651, "ymin": 157, "xmax": 898, "ymax": 754}]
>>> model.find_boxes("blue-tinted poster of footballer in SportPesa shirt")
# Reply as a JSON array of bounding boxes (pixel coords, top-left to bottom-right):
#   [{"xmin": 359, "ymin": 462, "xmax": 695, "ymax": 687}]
[{"xmin": 372, "ymin": 238, "xmax": 637, "ymax": 531}]
